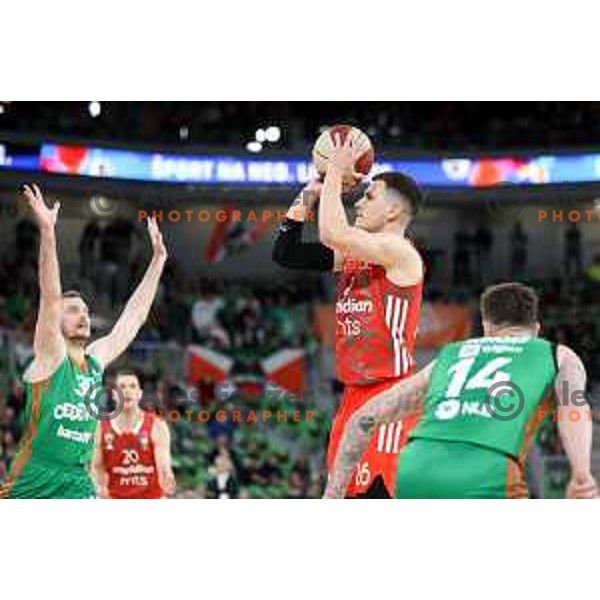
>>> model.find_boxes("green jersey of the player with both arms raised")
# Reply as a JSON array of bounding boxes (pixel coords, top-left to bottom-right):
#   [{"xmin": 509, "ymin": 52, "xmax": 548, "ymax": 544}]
[{"xmin": 5, "ymin": 357, "xmax": 102, "ymax": 493}]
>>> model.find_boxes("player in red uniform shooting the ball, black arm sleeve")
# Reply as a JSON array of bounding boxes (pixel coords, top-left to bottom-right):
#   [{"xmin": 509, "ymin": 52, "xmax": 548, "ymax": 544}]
[{"xmin": 273, "ymin": 132, "xmax": 423, "ymax": 498}]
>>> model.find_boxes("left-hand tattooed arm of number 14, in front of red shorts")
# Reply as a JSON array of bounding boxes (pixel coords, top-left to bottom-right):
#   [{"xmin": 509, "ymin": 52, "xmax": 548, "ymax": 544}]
[{"xmin": 324, "ymin": 362, "xmax": 434, "ymax": 499}]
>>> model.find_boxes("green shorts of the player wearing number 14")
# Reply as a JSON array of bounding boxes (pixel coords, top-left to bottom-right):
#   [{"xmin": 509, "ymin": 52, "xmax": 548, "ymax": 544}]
[{"xmin": 395, "ymin": 438, "xmax": 528, "ymax": 498}]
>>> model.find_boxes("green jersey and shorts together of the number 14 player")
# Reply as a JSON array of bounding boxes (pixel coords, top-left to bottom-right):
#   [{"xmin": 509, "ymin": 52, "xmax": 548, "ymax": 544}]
[{"xmin": 396, "ymin": 337, "xmax": 558, "ymax": 498}]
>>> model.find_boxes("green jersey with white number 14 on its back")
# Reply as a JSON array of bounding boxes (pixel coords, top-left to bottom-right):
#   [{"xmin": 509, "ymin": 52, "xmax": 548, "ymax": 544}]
[{"xmin": 410, "ymin": 337, "xmax": 557, "ymax": 458}]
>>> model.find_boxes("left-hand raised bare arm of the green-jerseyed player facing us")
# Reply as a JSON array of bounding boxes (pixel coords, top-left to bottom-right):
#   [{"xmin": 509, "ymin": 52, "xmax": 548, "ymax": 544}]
[{"xmin": 23, "ymin": 184, "xmax": 67, "ymax": 381}]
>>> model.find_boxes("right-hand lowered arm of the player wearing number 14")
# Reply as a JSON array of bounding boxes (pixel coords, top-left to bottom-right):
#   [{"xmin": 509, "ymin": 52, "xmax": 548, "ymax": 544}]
[{"xmin": 555, "ymin": 346, "xmax": 598, "ymax": 499}]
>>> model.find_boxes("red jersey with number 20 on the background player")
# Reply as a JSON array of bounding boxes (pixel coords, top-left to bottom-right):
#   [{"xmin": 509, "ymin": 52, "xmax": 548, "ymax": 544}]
[{"xmin": 101, "ymin": 411, "xmax": 162, "ymax": 499}]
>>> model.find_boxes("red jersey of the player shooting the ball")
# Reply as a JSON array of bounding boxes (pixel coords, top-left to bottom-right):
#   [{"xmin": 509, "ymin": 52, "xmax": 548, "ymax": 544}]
[{"xmin": 335, "ymin": 254, "xmax": 423, "ymax": 385}]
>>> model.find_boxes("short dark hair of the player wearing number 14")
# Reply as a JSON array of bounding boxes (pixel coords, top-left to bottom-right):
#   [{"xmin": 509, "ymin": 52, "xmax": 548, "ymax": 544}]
[{"xmin": 481, "ymin": 282, "xmax": 539, "ymax": 327}]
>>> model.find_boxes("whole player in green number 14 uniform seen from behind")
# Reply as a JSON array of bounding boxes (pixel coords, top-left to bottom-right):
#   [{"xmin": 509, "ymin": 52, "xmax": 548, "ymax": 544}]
[{"xmin": 325, "ymin": 283, "xmax": 600, "ymax": 498}]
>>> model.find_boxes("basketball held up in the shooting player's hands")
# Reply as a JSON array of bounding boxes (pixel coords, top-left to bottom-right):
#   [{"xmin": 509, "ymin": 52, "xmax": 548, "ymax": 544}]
[{"xmin": 312, "ymin": 125, "xmax": 375, "ymax": 189}]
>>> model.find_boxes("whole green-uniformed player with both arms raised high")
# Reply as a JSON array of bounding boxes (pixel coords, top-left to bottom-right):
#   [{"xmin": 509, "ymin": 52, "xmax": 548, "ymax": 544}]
[{"xmin": 0, "ymin": 185, "xmax": 167, "ymax": 498}]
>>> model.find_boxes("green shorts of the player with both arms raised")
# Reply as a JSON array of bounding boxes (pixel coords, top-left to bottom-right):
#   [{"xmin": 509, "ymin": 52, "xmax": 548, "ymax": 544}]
[{"xmin": 2, "ymin": 460, "xmax": 96, "ymax": 499}]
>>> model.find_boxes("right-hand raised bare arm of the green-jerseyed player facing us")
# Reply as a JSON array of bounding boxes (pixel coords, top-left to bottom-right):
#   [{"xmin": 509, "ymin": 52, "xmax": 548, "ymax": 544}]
[{"xmin": 87, "ymin": 219, "xmax": 167, "ymax": 367}]
